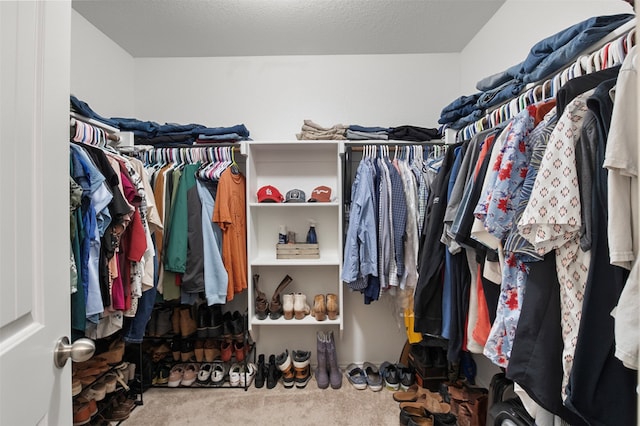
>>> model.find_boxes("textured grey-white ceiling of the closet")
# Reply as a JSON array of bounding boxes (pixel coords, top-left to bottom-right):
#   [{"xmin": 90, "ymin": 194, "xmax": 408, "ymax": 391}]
[{"xmin": 72, "ymin": 0, "xmax": 505, "ymax": 57}]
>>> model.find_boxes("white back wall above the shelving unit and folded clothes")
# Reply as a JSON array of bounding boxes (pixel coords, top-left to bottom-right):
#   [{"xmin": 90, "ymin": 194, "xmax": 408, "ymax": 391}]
[{"xmin": 135, "ymin": 54, "xmax": 459, "ymax": 140}]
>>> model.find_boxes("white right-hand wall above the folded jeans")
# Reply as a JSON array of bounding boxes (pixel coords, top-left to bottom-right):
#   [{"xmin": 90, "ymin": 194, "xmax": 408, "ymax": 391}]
[{"xmin": 458, "ymin": 0, "xmax": 633, "ymax": 93}]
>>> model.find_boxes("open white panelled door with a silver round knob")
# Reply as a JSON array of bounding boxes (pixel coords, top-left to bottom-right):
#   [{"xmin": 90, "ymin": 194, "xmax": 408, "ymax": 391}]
[{"xmin": 0, "ymin": 1, "xmax": 72, "ymax": 426}]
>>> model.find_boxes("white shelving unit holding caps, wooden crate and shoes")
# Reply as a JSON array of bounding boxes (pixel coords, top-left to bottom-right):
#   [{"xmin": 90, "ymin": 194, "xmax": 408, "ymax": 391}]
[{"xmin": 242, "ymin": 141, "xmax": 343, "ymax": 340}]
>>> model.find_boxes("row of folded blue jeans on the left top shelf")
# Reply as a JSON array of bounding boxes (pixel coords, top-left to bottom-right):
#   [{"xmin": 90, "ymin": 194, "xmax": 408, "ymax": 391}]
[{"xmin": 71, "ymin": 95, "xmax": 249, "ymax": 148}]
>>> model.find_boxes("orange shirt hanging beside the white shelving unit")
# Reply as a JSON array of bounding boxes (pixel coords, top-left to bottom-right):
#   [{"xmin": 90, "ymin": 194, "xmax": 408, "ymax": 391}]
[{"xmin": 212, "ymin": 168, "xmax": 247, "ymax": 301}]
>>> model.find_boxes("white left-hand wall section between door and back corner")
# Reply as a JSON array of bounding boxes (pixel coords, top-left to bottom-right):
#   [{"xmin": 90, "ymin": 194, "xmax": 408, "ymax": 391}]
[{"xmin": 71, "ymin": 10, "xmax": 135, "ymax": 118}]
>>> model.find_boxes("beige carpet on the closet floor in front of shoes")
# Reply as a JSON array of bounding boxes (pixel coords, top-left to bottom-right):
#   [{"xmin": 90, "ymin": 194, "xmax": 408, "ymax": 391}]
[{"xmin": 123, "ymin": 378, "xmax": 399, "ymax": 426}]
